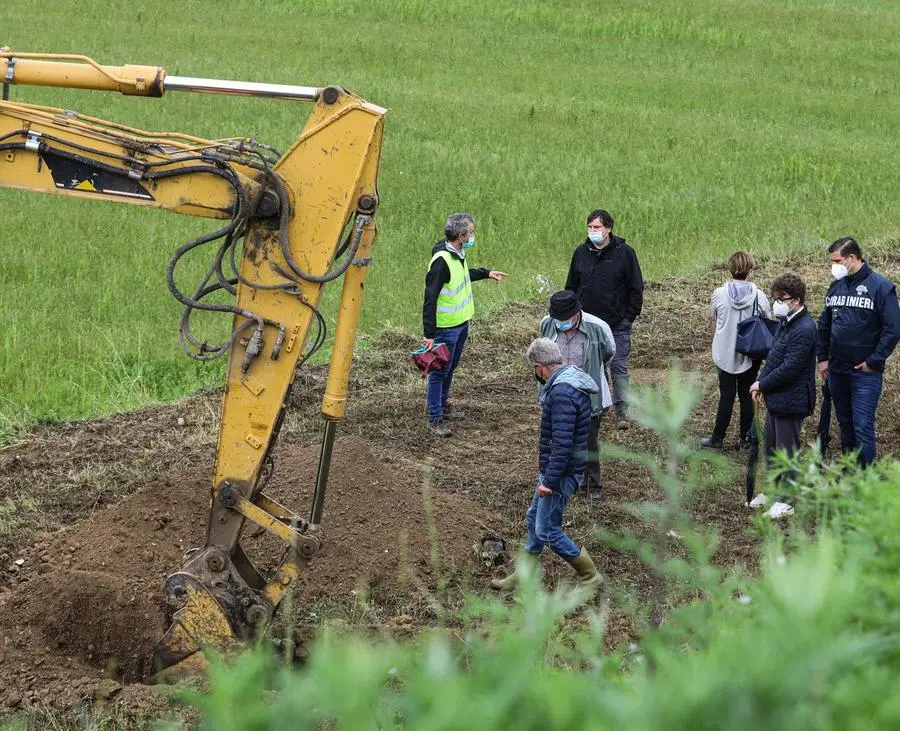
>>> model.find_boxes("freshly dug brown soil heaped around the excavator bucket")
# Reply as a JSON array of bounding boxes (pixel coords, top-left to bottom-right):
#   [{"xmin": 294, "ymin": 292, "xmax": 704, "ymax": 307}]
[{"xmin": 0, "ymin": 437, "xmax": 492, "ymax": 706}]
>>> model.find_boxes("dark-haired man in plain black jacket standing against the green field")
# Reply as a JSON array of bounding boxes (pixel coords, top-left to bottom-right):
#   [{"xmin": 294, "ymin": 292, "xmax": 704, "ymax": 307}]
[{"xmin": 566, "ymin": 209, "xmax": 644, "ymax": 429}]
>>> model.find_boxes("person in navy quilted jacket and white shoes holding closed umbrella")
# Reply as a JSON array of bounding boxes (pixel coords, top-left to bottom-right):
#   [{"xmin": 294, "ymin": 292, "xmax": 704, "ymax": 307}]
[{"xmin": 750, "ymin": 274, "xmax": 816, "ymax": 518}]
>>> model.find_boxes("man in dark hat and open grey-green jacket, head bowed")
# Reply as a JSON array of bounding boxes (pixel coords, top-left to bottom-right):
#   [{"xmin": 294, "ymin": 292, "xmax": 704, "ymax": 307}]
[{"xmin": 541, "ymin": 290, "xmax": 616, "ymax": 500}]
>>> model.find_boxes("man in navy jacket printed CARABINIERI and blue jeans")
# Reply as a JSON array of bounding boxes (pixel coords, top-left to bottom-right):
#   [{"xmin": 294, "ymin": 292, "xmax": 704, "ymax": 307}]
[{"xmin": 818, "ymin": 236, "xmax": 900, "ymax": 466}]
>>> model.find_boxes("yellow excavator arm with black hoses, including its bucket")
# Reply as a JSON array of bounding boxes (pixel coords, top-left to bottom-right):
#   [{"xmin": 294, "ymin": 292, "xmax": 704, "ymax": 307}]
[{"xmin": 0, "ymin": 49, "xmax": 385, "ymax": 675}]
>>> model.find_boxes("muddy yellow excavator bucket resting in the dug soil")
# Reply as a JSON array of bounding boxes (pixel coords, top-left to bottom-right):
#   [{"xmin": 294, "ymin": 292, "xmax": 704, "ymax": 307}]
[{"xmin": 153, "ymin": 573, "xmax": 241, "ymax": 681}]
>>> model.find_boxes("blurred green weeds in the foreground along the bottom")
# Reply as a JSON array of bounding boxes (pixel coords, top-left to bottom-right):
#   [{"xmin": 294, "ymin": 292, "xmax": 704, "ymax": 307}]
[{"xmin": 162, "ymin": 376, "xmax": 900, "ymax": 731}]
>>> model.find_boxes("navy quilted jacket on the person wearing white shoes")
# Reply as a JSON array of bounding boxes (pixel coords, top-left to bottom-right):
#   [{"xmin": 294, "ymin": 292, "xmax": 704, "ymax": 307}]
[{"xmin": 759, "ymin": 309, "xmax": 816, "ymax": 418}]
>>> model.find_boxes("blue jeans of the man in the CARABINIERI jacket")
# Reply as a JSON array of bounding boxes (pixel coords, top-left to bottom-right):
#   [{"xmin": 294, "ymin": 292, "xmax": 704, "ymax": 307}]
[{"xmin": 828, "ymin": 371, "xmax": 884, "ymax": 467}]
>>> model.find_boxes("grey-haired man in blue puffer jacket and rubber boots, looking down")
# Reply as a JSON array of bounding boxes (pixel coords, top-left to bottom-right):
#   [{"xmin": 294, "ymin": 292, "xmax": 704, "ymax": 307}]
[{"xmin": 491, "ymin": 338, "xmax": 600, "ymax": 590}]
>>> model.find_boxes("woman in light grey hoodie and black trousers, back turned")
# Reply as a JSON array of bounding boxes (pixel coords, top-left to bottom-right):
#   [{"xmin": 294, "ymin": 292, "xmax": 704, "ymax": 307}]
[{"xmin": 700, "ymin": 251, "xmax": 772, "ymax": 449}]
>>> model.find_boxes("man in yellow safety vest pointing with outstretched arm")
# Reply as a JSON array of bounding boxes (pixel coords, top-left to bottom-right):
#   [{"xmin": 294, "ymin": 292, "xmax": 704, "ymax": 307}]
[{"xmin": 422, "ymin": 213, "xmax": 507, "ymax": 437}]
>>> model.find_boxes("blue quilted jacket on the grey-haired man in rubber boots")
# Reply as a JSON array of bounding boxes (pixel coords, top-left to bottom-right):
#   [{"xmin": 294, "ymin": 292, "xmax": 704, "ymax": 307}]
[{"xmin": 540, "ymin": 366, "xmax": 600, "ymax": 490}]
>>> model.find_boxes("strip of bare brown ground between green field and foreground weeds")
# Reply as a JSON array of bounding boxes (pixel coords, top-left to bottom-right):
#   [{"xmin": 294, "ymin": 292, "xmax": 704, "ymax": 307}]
[{"xmin": 0, "ymin": 242, "xmax": 900, "ymax": 717}]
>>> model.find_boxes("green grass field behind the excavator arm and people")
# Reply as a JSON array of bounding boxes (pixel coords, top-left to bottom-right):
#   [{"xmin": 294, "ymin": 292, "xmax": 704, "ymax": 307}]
[{"xmin": 0, "ymin": 0, "xmax": 900, "ymax": 433}]
